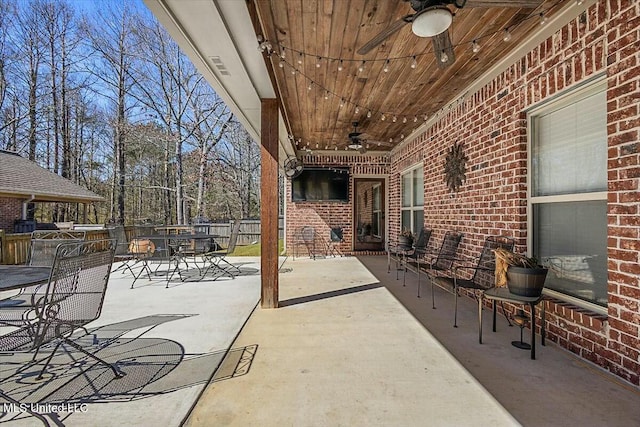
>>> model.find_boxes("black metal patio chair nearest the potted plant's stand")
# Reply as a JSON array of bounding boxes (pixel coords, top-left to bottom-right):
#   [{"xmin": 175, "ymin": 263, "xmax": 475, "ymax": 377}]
[{"xmin": 431, "ymin": 236, "xmax": 514, "ymax": 328}]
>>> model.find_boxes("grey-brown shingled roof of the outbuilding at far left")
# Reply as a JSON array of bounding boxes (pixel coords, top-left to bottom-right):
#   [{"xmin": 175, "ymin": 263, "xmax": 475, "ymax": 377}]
[{"xmin": 0, "ymin": 150, "xmax": 104, "ymax": 203}]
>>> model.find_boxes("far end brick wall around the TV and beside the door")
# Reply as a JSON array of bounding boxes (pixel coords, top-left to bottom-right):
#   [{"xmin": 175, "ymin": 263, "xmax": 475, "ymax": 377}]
[{"xmin": 285, "ymin": 154, "xmax": 389, "ymax": 255}]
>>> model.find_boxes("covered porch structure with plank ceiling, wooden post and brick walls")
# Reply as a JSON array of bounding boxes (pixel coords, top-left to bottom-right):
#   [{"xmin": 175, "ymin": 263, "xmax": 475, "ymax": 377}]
[{"xmin": 145, "ymin": 0, "xmax": 640, "ymax": 387}]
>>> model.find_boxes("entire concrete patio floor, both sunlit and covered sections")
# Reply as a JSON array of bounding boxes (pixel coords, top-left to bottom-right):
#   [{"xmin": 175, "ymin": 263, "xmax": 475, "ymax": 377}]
[{"xmin": 0, "ymin": 256, "xmax": 640, "ymax": 427}]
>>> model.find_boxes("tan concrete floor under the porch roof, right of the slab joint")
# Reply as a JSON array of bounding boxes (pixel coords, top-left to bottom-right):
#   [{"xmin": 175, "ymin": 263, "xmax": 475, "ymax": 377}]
[{"xmin": 186, "ymin": 256, "xmax": 640, "ymax": 427}]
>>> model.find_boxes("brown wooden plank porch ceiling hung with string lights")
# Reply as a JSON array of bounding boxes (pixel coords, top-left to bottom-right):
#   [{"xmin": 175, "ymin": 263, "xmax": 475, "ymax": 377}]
[{"xmin": 254, "ymin": 0, "xmax": 570, "ymax": 151}]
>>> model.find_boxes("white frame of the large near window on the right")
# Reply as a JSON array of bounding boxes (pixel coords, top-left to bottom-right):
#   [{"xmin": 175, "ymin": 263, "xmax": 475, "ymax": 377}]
[{"xmin": 527, "ymin": 76, "xmax": 608, "ymax": 314}]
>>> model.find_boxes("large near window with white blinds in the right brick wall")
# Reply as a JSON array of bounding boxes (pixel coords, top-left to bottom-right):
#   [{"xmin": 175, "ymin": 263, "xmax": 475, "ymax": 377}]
[{"xmin": 529, "ymin": 81, "xmax": 607, "ymax": 308}]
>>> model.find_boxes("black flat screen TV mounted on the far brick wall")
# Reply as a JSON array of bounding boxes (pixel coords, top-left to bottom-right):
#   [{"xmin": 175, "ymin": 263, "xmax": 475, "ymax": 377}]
[{"xmin": 291, "ymin": 167, "xmax": 349, "ymax": 202}]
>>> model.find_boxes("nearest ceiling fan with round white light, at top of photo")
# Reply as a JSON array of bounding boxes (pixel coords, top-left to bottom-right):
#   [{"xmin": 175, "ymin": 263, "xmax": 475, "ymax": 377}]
[{"xmin": 358, "ymin": 0, "xmax": 542, "ymax": 68}]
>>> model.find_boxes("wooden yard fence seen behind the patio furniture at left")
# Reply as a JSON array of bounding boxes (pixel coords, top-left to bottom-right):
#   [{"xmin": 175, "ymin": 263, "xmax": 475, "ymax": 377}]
[{"xmin": 0, "ymin": 217, "xmax": 284, "ymax": 264}]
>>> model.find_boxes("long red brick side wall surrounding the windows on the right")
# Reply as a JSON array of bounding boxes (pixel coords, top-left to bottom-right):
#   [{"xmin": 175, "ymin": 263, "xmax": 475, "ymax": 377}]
[{"xmin": 388, "ymin": 0, "xmax": 640, "ymax": 385}]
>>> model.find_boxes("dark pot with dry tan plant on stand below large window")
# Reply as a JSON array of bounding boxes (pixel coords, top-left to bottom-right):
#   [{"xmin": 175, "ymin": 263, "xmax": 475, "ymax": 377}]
[{"xmin": 495, "ymin": 249, "xmax": 549, "ymax": 297}]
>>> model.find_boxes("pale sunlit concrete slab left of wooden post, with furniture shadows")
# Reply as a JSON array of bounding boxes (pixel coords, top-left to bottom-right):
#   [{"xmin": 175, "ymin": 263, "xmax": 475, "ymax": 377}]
[{"xmin": 0, "ymin": 259, "xmax": 260, "ymax": 426}]
